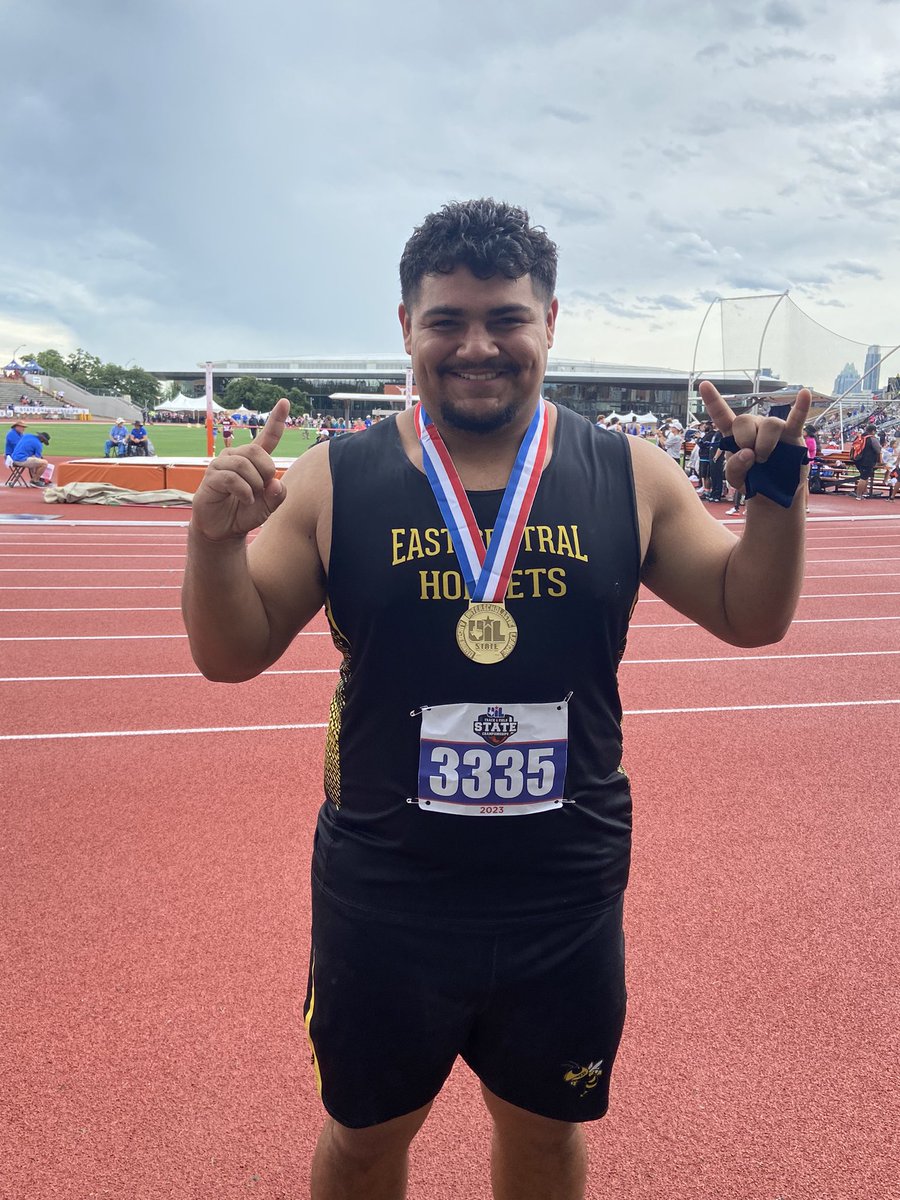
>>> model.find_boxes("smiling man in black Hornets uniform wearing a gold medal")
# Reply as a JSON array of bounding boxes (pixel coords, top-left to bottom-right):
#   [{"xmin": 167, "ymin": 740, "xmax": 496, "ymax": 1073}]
[{"xmin": 182, "ymin": 200, "xmax": 809, "ymax": 1200}]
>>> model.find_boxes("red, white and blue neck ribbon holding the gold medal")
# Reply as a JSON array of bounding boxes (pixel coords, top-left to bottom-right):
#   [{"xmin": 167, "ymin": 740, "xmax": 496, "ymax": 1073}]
[{"xmin": 414, "ymin": 396, "xmax": 550, "ymax": 604}]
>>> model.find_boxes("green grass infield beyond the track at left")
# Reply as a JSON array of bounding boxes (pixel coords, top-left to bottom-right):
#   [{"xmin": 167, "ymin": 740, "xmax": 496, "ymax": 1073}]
[{"xmin": 0, "ymin": 419, "xmax": 316, "ymax": 458}]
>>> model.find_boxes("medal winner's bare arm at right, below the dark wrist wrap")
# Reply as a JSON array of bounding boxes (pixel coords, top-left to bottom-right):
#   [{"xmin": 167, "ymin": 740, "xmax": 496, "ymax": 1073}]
[{"xmin": 630, "ymin": 412, "xmax": 804, "ymax": 647}]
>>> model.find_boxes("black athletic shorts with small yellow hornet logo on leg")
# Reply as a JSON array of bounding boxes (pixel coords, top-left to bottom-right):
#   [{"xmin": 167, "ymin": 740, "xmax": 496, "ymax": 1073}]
[{"xmin": 304, "ymin": 884, "xmax": 625, "ymax": 1128}]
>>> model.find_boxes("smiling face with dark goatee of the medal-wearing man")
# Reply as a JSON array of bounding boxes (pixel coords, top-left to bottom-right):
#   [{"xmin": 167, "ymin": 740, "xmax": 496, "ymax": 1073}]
[{"xmin": 400, "ymin": 266, "xmax": 557, "ymax": 433}]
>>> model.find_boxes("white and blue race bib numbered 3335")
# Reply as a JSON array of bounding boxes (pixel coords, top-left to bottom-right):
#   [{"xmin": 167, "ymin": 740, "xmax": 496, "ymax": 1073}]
[{"xmin": 415, "ymin": 701, "xmax": 569, "ymax": 817}]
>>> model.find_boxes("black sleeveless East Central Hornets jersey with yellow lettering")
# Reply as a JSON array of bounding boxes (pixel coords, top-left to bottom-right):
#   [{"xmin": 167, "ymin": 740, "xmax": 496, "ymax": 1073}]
[{"xmin": 313, "ymin": 408, "xmax": 640, "ymax": 924}]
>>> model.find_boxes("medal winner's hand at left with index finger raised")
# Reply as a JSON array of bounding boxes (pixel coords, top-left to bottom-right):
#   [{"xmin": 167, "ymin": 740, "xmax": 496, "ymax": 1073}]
[{"xmin": 191, "ymin": 397, "xmax": 290, "ymax": 541}]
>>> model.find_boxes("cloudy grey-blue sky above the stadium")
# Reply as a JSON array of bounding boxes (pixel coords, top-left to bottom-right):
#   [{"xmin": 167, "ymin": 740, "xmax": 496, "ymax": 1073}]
[{"xmin": 0, "ymin": 0, "xmax": 900, "ymax": 384}]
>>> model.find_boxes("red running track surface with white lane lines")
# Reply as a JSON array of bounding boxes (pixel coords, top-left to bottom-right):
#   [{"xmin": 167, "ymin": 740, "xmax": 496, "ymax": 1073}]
[{"xmin": 0, "ymin": 492, "xmax": 900, "ymax": 1200}]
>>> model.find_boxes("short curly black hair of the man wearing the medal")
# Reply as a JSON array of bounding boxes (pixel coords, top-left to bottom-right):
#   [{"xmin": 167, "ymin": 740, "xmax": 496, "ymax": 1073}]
[{"xmin": 400, "ymin": 197, "xmax": 557, "ymax": 308}]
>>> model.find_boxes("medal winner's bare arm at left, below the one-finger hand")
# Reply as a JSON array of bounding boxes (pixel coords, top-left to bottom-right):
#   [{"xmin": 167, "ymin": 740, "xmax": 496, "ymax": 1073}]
[{"xmin": 181, "ymin": 427, "xmax": 331, "ymax": 683}]
